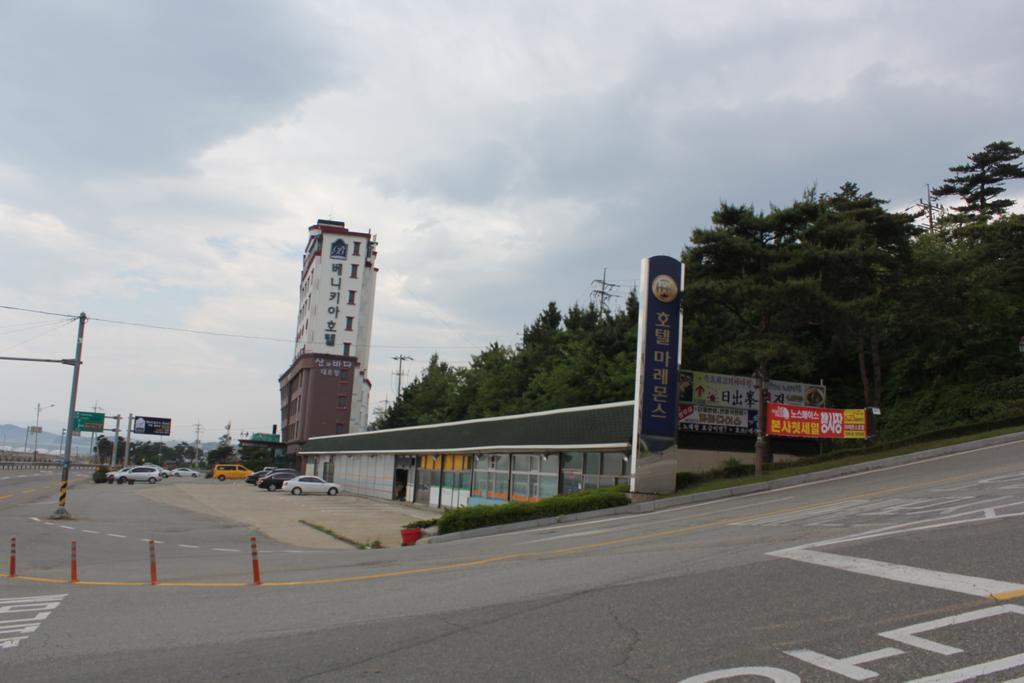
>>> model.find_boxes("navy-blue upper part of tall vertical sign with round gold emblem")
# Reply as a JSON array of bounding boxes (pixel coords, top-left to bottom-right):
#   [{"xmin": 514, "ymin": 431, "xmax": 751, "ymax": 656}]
[{"xmin": 634, "ymin": 256, "xmax": 683, "ymax": 456}]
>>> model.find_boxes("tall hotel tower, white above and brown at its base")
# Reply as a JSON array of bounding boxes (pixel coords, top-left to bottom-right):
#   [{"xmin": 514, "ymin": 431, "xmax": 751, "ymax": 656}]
[{"xmin": 279, "ymin": 219, "xmax": 377, "ymax": 454}]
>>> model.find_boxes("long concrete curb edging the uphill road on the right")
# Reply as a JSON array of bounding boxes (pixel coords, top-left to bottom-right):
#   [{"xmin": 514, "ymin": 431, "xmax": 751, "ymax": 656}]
[{"xmin": 429, "ymin": 432, "xmax": 1024, "ymax": 543}]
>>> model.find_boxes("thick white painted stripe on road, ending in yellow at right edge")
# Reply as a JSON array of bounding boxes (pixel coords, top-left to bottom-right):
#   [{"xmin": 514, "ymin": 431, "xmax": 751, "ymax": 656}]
[{"xmin": 767, "ymin": 547, "xmax": 1024, "ymax": 598}]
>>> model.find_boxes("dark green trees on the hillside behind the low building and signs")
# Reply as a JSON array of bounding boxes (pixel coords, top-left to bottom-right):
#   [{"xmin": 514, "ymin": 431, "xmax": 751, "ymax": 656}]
[{"xmin": 374, "ymin": 140, "xmax": 1024, "ymax": 438}]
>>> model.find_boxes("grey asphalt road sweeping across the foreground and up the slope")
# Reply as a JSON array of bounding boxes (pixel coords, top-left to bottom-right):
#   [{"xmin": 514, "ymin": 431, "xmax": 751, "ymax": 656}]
[{"xmin": 0, "ymin": 440, "xmax": 1024, "ymax": 683}]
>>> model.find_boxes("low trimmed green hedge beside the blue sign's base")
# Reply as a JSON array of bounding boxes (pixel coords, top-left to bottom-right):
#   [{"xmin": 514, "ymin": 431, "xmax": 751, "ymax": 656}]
[{"xmin": 437, "ymin": 486, "xmax": 630, "ymax": 533}]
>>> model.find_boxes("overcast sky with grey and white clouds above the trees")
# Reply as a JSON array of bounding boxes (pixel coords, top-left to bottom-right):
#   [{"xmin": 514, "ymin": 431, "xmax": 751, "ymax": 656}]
[{"xmin": 0, "ymin": 0, "xmax": 1024, "ymax": 446}]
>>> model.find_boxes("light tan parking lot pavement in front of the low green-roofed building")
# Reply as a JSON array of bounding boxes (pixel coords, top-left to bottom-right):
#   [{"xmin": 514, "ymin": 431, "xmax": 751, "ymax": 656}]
[{"xmin": 135, "ymin": 479, "xmax": 437, "ymax": 549}]
